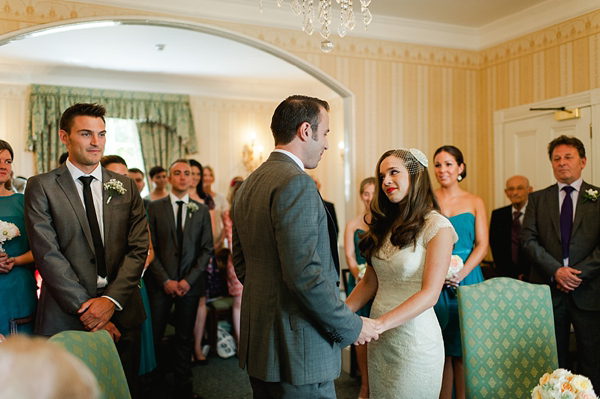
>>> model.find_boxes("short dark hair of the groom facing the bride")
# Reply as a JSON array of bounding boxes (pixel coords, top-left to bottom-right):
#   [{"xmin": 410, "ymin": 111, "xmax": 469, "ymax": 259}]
[{"xmin": 271, "ymin": 96, "xmax": 329, "ymax": 145}]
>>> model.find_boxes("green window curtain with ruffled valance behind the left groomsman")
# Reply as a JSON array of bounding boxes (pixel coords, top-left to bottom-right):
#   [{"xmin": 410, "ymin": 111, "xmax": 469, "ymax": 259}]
[{"xmin": 27, "ymin": 85, "xmax": 196, "ymax": 173}]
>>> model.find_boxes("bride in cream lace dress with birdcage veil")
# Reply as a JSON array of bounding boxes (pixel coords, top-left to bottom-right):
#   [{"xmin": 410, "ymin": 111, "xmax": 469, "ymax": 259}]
[{"xmin": 346, "ymin": 149, "xmax": 458, "ymax": 399}]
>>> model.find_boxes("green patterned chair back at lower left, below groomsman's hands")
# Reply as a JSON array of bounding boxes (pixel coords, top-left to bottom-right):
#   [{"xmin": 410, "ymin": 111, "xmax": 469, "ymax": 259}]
[{"xmin": 50, "ymin": 330, "xmax": 131, "ymax": 399}]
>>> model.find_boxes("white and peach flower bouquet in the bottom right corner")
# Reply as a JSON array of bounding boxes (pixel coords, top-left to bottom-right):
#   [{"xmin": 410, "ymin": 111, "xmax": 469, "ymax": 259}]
[{"xmin": 531, "ymin": 369, "xmax": 598, "ymax": 399}]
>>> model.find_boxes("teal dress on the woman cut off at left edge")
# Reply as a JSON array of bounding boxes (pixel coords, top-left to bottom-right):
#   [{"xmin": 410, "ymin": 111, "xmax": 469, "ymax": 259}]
[{"xmin": 0, "ymin": 194, "xmax": 37, "ymax": 336}]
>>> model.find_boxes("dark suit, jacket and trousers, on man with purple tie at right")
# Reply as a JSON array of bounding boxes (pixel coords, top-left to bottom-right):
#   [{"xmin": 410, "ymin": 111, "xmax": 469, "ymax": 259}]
[{"xmin": 521, "ymin": 182, "xmax": 600, "ymax": 386}]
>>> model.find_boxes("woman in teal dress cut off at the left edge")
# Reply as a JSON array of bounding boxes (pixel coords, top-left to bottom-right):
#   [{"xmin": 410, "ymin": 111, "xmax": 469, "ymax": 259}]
[{"xmin": 0, "ymin": 140, "xmax": 37, "ymax": 336}]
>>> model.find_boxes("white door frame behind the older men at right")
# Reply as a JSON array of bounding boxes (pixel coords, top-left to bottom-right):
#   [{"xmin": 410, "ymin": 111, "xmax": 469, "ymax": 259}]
[{"xmin": 493, "ymin": 89, "xmax": 600, "ymax": 209}]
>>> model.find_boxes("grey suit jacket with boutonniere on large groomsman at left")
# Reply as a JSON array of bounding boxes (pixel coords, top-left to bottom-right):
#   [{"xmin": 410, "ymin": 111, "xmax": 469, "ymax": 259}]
[{"xmin": 25, "ymin": 165, "xmax": 148, "ymax": 335}]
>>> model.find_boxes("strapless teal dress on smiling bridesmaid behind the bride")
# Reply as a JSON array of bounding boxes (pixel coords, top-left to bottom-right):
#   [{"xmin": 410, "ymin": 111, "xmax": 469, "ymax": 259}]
[{"xmin": 434, "ymin": 213, "xmax": 483, "ymax": 357}]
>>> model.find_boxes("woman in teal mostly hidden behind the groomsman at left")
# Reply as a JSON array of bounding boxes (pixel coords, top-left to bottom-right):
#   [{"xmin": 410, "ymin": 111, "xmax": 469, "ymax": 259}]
[{"xmin": 100, "ymin": 155, "xmax": 156, "ymax": 375}]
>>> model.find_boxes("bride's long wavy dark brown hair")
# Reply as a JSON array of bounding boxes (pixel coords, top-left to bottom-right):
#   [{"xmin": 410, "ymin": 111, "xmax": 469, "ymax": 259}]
[{"xmin": 358, "ymin": 150, "xmax": 440, "ymax": 265}]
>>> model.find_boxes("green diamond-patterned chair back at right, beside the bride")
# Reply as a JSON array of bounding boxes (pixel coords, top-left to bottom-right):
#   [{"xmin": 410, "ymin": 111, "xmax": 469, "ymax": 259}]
[{"xmin": 458, "ymin": 277, "xmax": 558, "ymax": 399}]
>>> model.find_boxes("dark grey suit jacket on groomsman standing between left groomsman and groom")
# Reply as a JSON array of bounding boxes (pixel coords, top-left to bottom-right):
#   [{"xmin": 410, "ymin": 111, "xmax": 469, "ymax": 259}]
[{"xmin": 148, "ymin": 196, "xmax": 214, "ymax": 294}]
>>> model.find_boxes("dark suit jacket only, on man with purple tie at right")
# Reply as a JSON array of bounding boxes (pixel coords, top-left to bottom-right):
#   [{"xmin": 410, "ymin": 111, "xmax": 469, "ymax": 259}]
[{"xmin": 521, "ymin": 181, "xmax": 600, "ymax": 310}]
